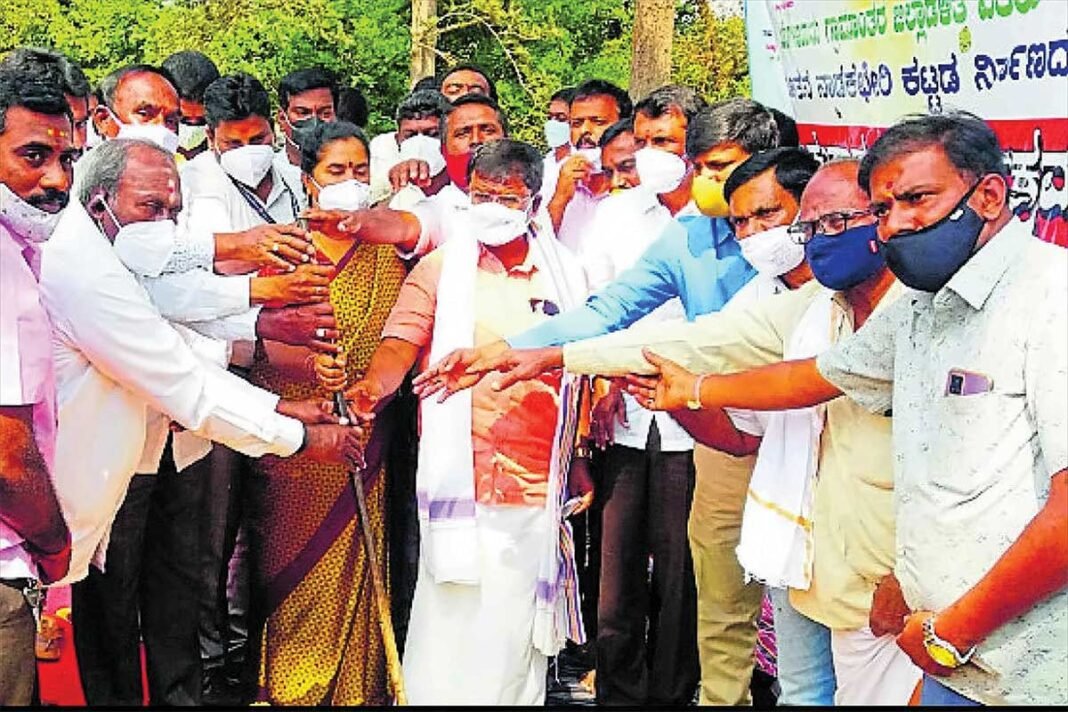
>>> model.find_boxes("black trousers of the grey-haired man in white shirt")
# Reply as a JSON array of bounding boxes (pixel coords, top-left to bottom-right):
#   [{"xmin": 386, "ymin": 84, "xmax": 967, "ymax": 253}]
[{"xmin": 72, "ymin": 444, "xmax": 208, "ymax": 706}]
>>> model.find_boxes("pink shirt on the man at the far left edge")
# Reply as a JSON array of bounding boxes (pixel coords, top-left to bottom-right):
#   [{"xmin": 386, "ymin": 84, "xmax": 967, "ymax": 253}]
[{"xmin": 0, "ymin": 218, "xmax": 56, "ymax": 579}]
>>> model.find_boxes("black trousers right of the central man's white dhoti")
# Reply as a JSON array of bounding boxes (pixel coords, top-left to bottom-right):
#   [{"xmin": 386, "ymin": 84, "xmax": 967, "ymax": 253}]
[{"xmin": 596, "ymin": 424, "xmax": 701, "ymax": 706}]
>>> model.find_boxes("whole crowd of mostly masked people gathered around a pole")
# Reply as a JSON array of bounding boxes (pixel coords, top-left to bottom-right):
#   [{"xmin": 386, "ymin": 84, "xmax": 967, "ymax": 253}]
[{"xmin": 0, "ymin": 48, "xmax": 1068, "ymax": 707}]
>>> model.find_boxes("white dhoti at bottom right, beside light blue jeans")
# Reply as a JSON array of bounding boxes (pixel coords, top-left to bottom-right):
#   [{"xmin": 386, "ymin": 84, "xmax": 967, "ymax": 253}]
[{"xmin": 831, "ymin": 627, "xmax": 923, "ymax": 707}]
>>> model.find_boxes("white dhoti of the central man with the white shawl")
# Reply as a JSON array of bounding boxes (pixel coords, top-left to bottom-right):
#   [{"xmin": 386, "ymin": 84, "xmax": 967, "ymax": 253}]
[{"xmin": 404, "ymin": 505, "xmax": 547, "ymax": 707}]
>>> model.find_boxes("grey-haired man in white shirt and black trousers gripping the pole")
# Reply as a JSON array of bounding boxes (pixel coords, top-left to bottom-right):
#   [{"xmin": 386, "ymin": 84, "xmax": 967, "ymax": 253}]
[{"xmin": 42, "ymin": 136, "xmax": 360, "ymax": 703}]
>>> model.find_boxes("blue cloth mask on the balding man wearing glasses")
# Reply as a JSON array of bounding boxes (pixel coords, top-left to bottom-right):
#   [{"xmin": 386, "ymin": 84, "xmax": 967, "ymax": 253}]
[{"xmin": 804, "ymin": 223, "xmax": 886, "ymax": 291}]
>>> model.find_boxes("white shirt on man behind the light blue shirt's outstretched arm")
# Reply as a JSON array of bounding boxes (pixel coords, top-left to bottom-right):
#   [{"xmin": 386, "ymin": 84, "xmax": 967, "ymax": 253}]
[{"xmin": 576, "ymin": 188, "xmax": 693, "ymax": 453}]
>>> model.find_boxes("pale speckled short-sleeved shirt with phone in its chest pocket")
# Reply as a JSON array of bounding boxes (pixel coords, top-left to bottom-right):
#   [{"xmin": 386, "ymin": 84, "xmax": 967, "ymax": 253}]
[{"xmin": 818, "ymin": 221, "xmax": 1068, "ymax": 705}]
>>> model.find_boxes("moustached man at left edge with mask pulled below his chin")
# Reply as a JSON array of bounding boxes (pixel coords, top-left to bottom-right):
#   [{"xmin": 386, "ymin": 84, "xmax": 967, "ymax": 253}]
[{"xmin": 0, "ymin": 66, "xmax": 78, "ymax": 707}]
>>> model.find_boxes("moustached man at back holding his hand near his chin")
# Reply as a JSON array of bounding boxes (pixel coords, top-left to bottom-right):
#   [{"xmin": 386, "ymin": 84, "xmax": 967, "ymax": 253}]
[{"xmin": 540, "ymin": 79, "xmax": 632, "ymax": 253}]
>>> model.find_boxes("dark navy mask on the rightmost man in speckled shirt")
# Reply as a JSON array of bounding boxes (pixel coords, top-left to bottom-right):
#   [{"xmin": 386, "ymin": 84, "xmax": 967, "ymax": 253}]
[{"xmin": 880, "ymin": 183, "xmax": 987, "ymax": 292}]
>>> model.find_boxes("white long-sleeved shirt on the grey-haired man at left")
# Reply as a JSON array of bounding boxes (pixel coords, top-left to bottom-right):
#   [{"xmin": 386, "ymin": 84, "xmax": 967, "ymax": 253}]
[{"xmin": 41, "ymin": 201, "xmax": 304, "ymax": 582}]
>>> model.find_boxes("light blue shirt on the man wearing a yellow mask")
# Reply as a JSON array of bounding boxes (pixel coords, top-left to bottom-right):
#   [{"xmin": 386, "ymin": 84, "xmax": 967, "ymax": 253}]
[{"xmin": 508, "ymin": 215, "xmax": 756, "ymax": 348}]
